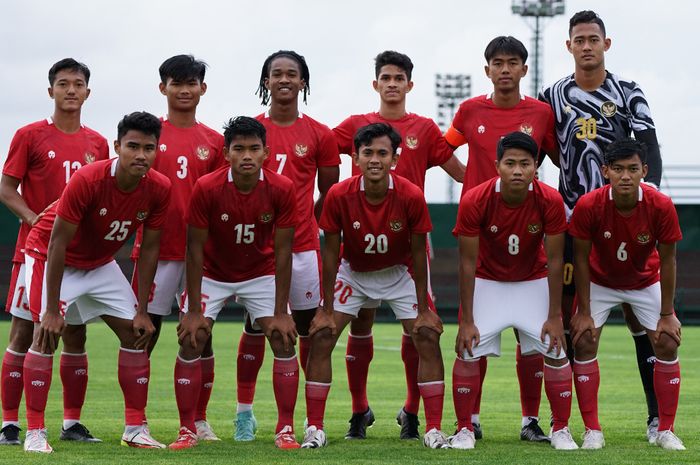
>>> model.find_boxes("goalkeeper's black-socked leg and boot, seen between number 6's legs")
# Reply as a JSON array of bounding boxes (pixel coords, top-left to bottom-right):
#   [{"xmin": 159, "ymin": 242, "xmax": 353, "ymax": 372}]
[{"xmin": 622, "ymin": 303, "xmax": 659, "ymax": 443}]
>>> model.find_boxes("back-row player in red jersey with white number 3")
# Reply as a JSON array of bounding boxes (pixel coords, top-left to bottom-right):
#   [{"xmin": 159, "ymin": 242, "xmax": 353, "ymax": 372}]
[{"xmin": 132, "ymin": 55, "xmax": 226, "ymax": 441}]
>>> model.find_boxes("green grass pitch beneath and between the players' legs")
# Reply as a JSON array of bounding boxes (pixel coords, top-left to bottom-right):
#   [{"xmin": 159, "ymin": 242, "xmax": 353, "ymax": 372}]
[{"xmin": 0, "ymin": 322, "xmax": 700, "ymax": 465}]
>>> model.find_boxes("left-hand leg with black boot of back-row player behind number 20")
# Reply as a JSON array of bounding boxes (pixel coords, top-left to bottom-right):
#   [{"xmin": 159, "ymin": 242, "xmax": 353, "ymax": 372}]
[{"xmin": 345, "ymin": 308, "xmax": 377, "ymax": 439}]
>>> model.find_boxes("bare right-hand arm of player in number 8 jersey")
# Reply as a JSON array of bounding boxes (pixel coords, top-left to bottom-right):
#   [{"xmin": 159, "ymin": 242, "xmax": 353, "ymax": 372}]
[{"xmin": 540, "ymin": 233, "xmax": 566, "ymax": 354}]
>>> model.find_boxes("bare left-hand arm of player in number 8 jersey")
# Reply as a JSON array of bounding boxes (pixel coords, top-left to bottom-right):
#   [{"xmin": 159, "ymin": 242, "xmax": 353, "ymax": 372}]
[{"xmin": 455, "ymin": 235, "xmax": 479, "ymax": 357}]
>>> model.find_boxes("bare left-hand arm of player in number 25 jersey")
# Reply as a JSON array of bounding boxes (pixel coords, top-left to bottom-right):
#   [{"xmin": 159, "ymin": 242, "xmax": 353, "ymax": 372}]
[{"xmin": 37, "ymin": 216, "xmax": 78, "ymax": 353}]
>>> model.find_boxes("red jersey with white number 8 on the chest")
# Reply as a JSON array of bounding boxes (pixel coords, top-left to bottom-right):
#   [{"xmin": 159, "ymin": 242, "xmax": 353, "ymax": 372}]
[{"xmin": 452, "ymin": 178, "xmax": 566, "ymax": 282}]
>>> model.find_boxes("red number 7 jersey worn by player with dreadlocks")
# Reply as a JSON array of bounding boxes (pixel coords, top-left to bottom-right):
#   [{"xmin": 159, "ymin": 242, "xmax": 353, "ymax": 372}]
[{"xmin": 257, "ymin": 113, "xmax": 340, "ymax": 252}]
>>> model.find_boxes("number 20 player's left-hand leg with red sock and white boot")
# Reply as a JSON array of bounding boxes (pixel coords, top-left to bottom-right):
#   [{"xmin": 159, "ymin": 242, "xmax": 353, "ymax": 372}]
[{"xmin": 301, "ymin": 308, "xmax": 353, "ymax": 449}]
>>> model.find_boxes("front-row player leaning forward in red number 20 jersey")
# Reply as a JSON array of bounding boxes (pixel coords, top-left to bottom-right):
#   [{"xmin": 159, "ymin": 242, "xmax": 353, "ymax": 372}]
[{"xmin": 302, "ymin": 123, "xmax": 448, "ymax": 449}]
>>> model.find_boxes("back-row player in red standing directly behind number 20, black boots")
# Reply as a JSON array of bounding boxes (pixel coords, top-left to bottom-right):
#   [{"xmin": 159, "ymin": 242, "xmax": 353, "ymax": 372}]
[{"xmin": 333, "ymin": 51, "xmax": 464, "ymax": 439}]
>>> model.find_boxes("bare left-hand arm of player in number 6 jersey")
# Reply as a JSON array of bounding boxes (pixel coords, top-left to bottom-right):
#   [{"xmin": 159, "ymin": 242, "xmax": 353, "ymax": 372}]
[{"xmin": 571, "ymin": 237, "xmax": 595, "ymax": 346}]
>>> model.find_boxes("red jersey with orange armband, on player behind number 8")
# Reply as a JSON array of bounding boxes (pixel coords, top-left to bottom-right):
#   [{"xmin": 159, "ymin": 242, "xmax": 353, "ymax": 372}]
[{"xmin": 445, "ymin": 95, "xmax": 557, "ymax": 196}]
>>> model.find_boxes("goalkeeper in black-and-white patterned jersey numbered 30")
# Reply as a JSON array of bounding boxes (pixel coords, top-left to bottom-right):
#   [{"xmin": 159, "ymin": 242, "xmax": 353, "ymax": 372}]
[{"xmin": 540, "ymin": 11, "xmax": 661, "ymax": 440}]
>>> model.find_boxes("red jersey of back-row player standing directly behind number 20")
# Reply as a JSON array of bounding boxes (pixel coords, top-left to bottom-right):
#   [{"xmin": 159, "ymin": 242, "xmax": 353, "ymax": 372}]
[{"xmin": 333, "ymin": 112, "xmax": 454, "ymax": 190}]
